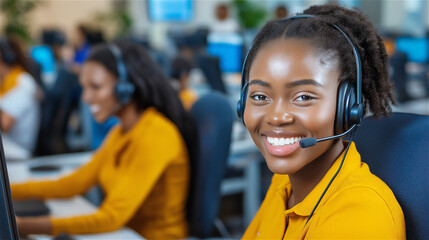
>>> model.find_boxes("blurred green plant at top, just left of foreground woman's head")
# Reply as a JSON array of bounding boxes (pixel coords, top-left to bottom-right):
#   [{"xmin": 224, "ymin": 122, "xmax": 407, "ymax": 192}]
[{"xmin": 233, "ymin": 0, "xmax": 267, "ymax": 29}]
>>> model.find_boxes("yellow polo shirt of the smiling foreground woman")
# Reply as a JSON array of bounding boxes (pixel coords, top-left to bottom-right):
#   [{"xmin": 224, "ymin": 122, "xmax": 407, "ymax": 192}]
[{"xmin": 243, "ymin": 143, "xmax": 405, "ymax": 239}]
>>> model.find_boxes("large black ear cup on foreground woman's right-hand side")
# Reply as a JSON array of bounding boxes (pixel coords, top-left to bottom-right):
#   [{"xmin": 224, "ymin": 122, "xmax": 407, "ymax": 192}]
[{"xmin": 334, "ymin": 81, "xmax": 356, "ymax": 135}]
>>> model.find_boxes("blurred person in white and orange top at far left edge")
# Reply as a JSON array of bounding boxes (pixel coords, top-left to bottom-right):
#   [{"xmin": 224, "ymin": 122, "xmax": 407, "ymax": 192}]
[{"xmin": 0, "ymin": 37, "xmax": 41, "ymax": 158}]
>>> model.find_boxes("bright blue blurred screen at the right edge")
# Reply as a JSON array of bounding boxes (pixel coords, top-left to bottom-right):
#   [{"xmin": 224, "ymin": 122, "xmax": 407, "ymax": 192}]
[{"xmin": 396, "ymin": 37, "xmax": 429, "ymax": 63}]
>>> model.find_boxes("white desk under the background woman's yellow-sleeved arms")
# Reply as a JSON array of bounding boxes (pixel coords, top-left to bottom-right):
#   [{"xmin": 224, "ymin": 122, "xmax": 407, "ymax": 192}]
[{"xmin": 7, "ymin": 152, "xmax": 144, "ymax": 240}]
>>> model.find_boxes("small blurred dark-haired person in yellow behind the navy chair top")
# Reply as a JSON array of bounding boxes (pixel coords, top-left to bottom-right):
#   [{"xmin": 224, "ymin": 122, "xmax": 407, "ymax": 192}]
[{"xmin": 171, "ymin": 56, "xmax": 198, "ymax": 111}]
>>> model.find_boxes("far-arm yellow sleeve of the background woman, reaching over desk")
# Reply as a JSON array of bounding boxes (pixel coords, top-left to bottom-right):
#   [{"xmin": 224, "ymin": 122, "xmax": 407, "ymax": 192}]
[{"xmin": 11, "ymin": 152, "xmax": 103, "ymax": 200}]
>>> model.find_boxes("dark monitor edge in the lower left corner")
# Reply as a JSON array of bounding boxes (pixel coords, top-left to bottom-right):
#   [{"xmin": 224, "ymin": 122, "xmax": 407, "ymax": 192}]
[{"xmin": 0, "ymin": 133, "xmax": 19, "ymax": 240}]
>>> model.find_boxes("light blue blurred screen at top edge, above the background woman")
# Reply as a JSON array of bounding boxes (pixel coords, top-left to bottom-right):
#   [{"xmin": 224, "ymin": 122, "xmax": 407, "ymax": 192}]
[{"xmin": 147, "ymin": 0, "xmax": 194, "ymax": 22}]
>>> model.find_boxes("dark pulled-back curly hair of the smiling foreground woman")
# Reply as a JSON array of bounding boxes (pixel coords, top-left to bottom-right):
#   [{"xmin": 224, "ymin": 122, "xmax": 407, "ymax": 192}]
[{"xmin": 245, "ymin": 5, "xmax": 395, "ymax": 117}]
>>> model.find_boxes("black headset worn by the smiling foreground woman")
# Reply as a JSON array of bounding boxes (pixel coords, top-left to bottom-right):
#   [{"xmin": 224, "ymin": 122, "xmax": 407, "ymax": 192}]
[{"xmin": 237, "ymin": 14, "xmax": 363, "ymax": 135}]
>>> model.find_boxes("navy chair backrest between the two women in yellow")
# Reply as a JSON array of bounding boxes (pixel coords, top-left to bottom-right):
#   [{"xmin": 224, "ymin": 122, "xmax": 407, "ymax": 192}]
[{"xmin": 188, "ymin": 92, "xmax": 234, "ymax": 238}]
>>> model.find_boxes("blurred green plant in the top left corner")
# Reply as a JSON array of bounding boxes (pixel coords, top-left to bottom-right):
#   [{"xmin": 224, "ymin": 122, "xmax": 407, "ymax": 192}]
[{"xmin": 0, "ymin": 0, "xmax": 40, "ymax": 42}]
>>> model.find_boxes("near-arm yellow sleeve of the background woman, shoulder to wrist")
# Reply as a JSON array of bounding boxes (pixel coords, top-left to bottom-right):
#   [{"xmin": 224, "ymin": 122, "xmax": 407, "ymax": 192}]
[{"xmin": 52, "ymin": 120, "xmax": 183, "ymax": 234}]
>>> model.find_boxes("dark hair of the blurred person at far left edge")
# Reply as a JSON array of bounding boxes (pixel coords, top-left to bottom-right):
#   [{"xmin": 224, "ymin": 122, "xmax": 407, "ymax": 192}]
[{"xmin": 0, "ymin": 37, "xmax": 33, "ymax": 75}]
